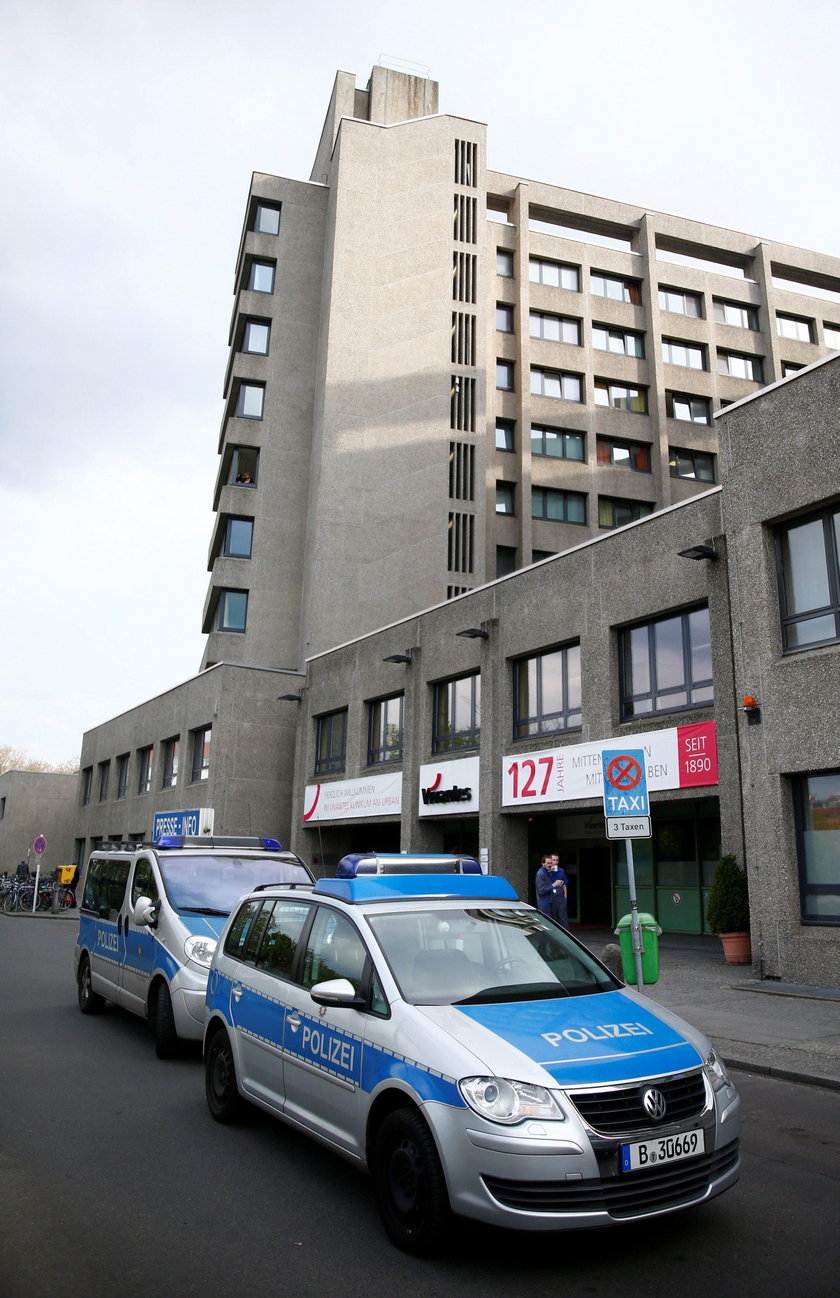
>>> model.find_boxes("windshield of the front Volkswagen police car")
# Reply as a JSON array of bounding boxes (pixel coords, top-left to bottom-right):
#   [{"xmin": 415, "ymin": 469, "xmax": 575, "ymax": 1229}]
[{"xmin": 369, "ymin": 907, "xmax": 618, "ymax": 1005}]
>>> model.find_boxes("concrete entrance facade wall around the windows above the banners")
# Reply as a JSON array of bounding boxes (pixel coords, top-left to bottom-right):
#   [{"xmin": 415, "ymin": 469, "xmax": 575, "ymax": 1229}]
[{"xmin": 293, "ymin": 489, "xmax": 721, "ymax": 893}]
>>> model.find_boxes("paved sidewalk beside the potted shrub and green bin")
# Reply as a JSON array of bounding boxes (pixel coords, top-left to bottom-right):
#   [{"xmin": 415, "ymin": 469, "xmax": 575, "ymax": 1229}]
[{"xmin": 584, "ymin": 929, "xmax": 840, "ymax": 1090}]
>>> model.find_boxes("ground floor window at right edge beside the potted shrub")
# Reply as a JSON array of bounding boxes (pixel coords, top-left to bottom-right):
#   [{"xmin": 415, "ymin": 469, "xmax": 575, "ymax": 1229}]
[{"xmin": 793, "ymin": 771, "xmax": 840, "ymax": 924}]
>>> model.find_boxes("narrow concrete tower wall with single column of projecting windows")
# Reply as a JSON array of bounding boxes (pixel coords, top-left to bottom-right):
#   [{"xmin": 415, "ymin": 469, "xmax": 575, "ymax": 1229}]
[{"xmin": 203, "ymin": 174, "xmax": 327, "ymax": 668}]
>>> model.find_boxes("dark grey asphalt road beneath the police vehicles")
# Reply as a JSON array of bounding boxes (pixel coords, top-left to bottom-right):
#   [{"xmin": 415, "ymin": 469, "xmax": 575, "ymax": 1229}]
[{"xmin": 0, "ymin": 918, "xmax": 840, "ymax": 1298}]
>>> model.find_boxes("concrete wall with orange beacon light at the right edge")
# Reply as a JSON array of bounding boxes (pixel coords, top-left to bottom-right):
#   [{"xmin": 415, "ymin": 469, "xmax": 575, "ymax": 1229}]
[{"xmin": 718, "ymin": 358, "xmax": 840, "ymax": 986}]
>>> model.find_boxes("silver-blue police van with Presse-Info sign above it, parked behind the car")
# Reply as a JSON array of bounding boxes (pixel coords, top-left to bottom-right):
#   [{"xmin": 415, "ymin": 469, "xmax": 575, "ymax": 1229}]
[{"xmin": 75, "ymin": 835, "xmax": 312, "ymax": 1059}]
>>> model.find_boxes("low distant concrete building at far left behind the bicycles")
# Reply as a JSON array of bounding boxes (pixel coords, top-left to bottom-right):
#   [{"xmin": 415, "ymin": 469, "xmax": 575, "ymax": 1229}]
[{"xmin": 0, "ymin": 771, "xmax": 79, "ymax": 874}]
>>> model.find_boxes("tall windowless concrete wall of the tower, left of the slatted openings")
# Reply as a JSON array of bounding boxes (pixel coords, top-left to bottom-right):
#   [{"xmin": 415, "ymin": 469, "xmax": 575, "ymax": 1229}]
[{"xmin": 305, "ymin": 117, "xmax": 483, "ymax": 652}]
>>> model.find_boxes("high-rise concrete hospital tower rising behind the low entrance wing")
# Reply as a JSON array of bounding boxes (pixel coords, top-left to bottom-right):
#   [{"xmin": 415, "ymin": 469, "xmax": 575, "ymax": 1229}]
[{"xmin": 204, "ymin": 59, "xmax": 840, "ymax": 667}]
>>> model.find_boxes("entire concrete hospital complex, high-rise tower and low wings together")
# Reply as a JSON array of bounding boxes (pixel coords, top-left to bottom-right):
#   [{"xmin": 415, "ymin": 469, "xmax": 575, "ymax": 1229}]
[{"xmin": 63, "ymin": 58, "xmax": 840, "ymax": 981}]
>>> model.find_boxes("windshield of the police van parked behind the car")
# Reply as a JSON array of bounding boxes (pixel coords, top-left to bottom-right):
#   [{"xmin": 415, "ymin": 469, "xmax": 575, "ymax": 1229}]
[{"xmin": 158, "ymin": 851, "xmax": 312, "ymax": 915}]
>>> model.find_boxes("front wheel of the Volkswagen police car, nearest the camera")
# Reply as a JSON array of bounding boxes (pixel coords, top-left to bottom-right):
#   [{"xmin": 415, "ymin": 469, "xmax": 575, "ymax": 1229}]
[{"xmin": 371, "ymin": 1108, "xmax": 449, "ymax": 1256}]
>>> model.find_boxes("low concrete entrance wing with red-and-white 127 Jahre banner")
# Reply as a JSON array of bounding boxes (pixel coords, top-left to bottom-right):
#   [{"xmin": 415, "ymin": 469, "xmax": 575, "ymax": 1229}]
[{"xmin": 293, "ymin": 357, "xmax": 840, "ymax": 985}]
